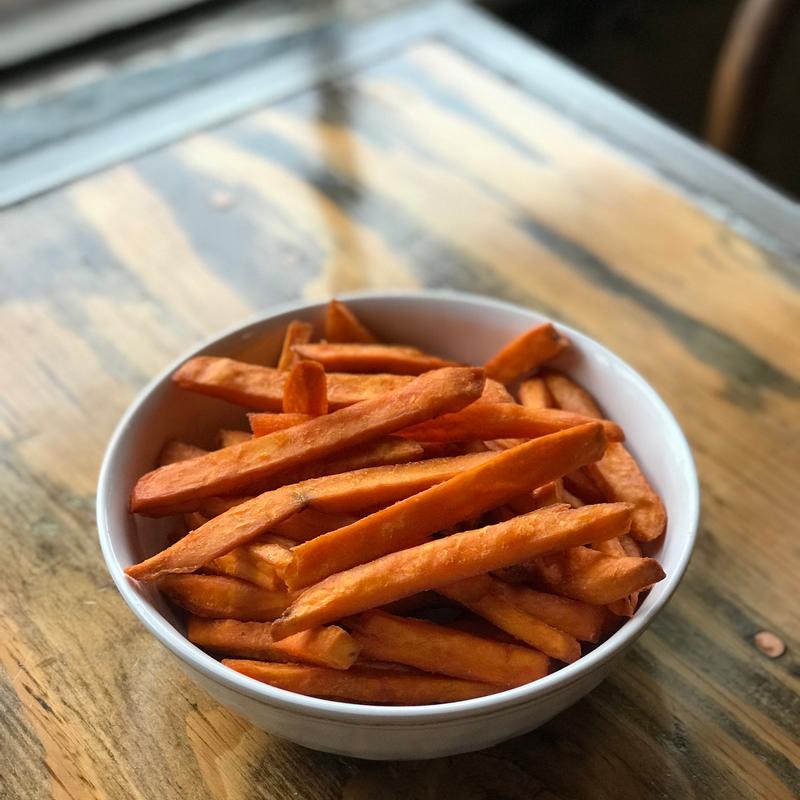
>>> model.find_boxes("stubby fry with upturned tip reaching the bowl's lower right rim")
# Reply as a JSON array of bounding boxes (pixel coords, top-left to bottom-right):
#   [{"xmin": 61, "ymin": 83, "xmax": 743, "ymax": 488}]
[{"xmin": 537, "ymin": 552, "xmax": 664, "ymax": 606}]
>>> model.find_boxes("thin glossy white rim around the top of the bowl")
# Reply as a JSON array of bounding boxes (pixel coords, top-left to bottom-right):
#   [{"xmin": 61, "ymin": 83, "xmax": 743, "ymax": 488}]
[{"xmin": 96, "ymin": 289, "xmax": 700, "ymax": 727}]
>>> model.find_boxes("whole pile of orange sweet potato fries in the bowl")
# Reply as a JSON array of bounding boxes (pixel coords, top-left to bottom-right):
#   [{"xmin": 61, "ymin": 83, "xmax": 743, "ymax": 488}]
[{"xmin": 126, "ymin": 300, "xmax": 666, "ymax": 705}]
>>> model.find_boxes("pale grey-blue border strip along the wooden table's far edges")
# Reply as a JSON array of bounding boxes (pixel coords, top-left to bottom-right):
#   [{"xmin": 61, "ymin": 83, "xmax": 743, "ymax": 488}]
[{"xmin": 0, "ymin": 0, "xmax": 800, "ymax": 258}]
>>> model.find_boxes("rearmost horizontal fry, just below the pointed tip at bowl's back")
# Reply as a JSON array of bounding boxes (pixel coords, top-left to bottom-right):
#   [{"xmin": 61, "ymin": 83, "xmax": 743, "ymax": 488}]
[{"xmin": 294, "ymin": 342, "xmax": 456, "ymax": 375}]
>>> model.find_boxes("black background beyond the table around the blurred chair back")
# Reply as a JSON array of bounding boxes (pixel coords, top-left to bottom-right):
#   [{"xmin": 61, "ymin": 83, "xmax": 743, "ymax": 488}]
[{"xmin": 482, "ymin": 0, "xmax": 800, "ymax": 197}]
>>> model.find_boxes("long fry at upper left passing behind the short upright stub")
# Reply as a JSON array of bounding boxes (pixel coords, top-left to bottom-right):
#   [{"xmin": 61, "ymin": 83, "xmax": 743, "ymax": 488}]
[{"xmin": 172, "ymin": 356, "xmax": 512, "ymax": 411}]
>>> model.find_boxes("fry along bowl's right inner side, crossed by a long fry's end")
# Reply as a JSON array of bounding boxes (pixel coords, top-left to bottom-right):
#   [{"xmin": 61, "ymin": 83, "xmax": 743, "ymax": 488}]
[{"xmin": 545, "ymin": 372, "xmax": 667, "ymax": 542}]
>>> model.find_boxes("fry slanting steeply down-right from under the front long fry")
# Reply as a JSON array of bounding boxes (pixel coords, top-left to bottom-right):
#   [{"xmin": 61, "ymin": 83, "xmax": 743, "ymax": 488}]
[{"xmin": 437, "ymin": 575, "xmax": 581, "ymax": 664}]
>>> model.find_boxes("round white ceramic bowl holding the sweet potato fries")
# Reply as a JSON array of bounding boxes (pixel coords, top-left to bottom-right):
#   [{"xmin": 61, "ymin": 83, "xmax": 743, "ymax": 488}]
[{"xmin": 97, "ymin": 292, "xmax": 699, "ymax": 759}]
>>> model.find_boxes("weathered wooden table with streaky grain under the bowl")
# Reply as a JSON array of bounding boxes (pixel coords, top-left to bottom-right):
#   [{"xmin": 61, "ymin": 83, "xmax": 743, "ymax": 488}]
[{"xmin": 0, "ymin": 5, "xmax": 800, "ymax": 800}]
